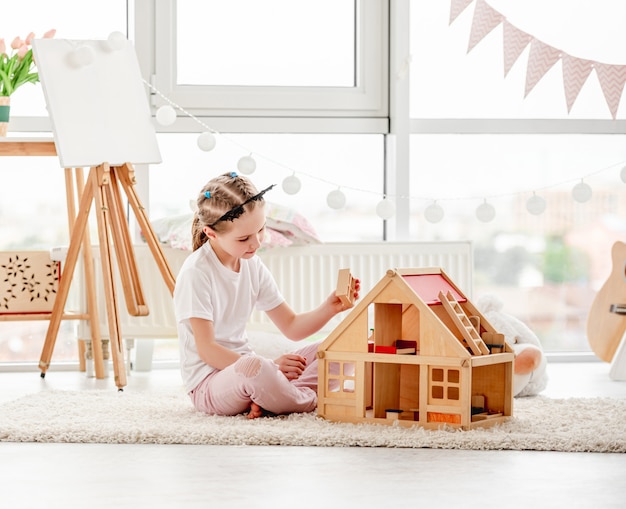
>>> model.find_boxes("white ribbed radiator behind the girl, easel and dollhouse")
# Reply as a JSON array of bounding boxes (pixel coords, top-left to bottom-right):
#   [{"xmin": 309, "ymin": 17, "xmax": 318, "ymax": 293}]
[{"xmin": 78, "ymin": 241, "xmax": 473, "ymax": 339}]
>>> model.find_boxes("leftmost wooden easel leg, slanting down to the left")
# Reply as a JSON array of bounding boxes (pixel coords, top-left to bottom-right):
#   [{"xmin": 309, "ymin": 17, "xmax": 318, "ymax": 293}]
[{"xmin": 39, "ymin": 169, "xmax": 95, "ymax": 378}]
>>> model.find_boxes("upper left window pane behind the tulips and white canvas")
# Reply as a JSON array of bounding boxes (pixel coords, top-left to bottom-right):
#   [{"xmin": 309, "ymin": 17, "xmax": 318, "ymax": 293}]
[{"xmin": 0, "ymin": 0, "xmax": 126, "ymax": 117}]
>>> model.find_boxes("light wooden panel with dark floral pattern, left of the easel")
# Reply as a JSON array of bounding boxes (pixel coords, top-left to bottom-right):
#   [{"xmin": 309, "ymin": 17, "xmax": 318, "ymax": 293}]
[{"xmin": 0, "ymin": 251, "xmax": 61, "ymax": 314}]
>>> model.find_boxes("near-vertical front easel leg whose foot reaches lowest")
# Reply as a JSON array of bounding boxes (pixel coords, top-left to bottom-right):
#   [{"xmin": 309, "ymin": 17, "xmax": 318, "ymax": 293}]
[{"xmin": 92, "ymin": 164, "xmax": 126, "ymax": 390}]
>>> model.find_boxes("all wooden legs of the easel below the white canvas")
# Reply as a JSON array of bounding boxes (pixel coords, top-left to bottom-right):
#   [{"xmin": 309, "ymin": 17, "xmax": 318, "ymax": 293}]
[{"xmin": 39, "ymin": 164, "xmax": 175, "ymax": 390}]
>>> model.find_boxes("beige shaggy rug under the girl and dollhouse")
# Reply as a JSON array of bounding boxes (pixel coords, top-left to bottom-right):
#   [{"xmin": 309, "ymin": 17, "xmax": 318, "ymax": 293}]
[{"xmin": 0, "ymin": 391, "xmax": 626, "ymax": 453}]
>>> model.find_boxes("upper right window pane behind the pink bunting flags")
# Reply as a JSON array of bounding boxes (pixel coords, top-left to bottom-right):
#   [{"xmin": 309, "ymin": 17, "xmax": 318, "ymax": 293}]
[{"xmin": 410, "ymin": 0, "xmax": 626, "ymax": 119}]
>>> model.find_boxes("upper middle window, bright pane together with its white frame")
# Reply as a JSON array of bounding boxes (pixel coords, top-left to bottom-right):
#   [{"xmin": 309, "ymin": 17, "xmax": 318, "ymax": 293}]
[{"xmin": 154, "ymin": 0, "xmax": 387, "ymax": 118}]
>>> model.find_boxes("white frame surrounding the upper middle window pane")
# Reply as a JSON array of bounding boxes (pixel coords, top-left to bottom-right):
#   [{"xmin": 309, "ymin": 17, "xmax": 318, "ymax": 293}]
[{"xmin": 141, "ymin": 0, "xmax": 389, "ymax": 133}]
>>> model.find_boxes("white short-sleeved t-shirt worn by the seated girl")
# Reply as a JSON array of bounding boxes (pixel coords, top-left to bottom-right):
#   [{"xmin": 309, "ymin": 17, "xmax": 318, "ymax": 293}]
[{"xmin": 174, "ymin": 242, "xmax": 284, "ymax": 392}]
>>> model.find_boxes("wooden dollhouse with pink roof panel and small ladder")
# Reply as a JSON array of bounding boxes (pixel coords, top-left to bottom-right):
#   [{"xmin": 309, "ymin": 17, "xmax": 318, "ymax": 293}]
[{"xmin": 317, "ymin": 268, "xmax": 514, "ymax": 430}]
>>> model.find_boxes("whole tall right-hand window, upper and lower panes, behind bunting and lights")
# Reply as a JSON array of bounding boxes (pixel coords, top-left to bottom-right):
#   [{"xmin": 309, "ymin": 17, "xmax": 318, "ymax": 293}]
[{"xmin": 409, "ymin": 0, "xmax": 626, "ymax": 352}]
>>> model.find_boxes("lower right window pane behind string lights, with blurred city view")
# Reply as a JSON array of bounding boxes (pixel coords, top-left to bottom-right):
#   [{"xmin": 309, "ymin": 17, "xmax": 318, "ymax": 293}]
[{"xmin": 411, "ymin": 134, "xmax": 626, "ymax": 351}]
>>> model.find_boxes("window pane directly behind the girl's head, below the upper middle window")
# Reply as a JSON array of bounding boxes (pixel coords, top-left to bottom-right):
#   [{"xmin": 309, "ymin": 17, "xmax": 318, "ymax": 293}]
[{"xmin": 150, "ymin": 134, "xmax": 384, "ymax": 242}]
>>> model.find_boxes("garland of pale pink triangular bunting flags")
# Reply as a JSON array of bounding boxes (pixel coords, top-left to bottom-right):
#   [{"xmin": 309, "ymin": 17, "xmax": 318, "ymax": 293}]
[{"xmin": 450, "ymin": 0, "xmax": 626, "ymax": 120}]
